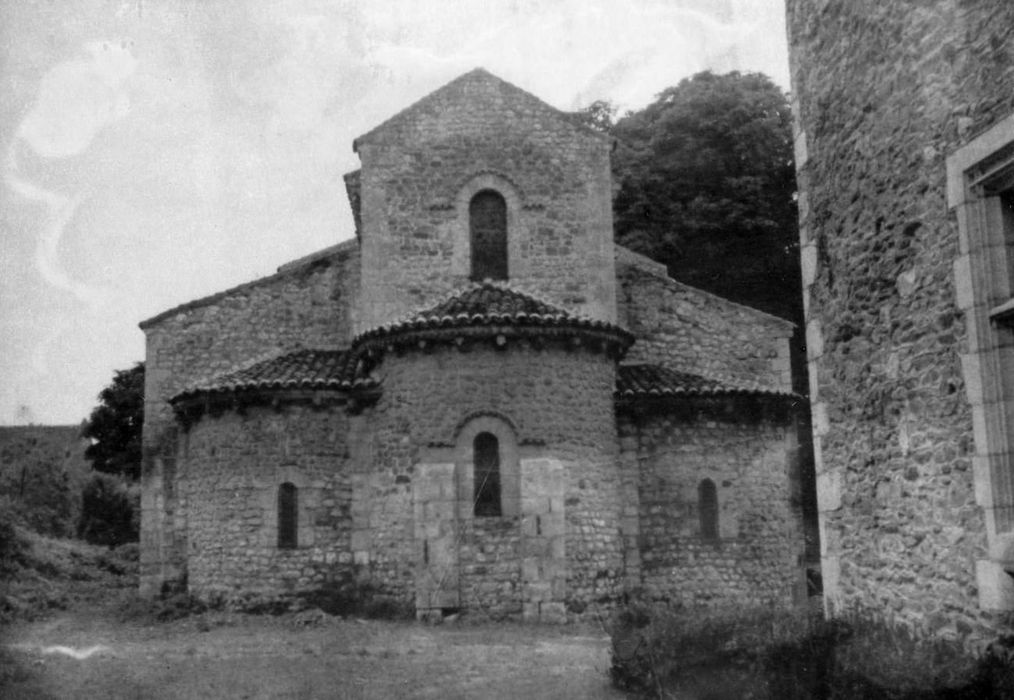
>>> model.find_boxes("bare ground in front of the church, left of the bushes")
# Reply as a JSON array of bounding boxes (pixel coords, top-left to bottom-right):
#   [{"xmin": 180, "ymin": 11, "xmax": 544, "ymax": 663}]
[{"xmin": 0, "ymin": 607, "xmax": 626, "ymax": 700}]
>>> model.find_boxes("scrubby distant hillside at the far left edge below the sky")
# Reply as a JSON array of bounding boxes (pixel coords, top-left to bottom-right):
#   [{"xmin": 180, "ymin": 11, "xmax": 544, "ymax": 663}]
[{"xmin": 0, "ymin": 425, "xmax": 91, "ymax": 537}]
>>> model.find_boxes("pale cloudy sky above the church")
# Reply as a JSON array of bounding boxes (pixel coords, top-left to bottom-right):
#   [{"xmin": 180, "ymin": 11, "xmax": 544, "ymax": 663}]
[{"xmin": 0, "ymin": 0, "xmax": 788, "ymax": 424}]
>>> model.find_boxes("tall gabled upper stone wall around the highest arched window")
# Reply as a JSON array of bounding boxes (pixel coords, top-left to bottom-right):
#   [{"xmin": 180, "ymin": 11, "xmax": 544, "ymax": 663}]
[{"xmin": 357, "ymin": 71, "xmax": 615, "ymax": 330}]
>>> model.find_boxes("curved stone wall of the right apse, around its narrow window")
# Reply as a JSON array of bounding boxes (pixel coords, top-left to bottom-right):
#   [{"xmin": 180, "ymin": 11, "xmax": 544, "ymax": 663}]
[{"xmin": 620, "ymin": 413, "xmax": 805, "ymax": 606}]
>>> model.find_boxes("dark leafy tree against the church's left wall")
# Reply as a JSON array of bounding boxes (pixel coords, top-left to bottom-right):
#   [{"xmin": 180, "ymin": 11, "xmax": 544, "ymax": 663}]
[{"xmin": 81, "ymin": 362, "xmax": 144, "ymax": 479}]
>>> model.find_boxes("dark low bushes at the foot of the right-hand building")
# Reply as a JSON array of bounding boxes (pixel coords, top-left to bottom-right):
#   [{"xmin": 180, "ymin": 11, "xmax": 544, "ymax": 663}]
[{"xmin": 610, "ymin": 605, "xmax": 1014, "ymax": 700}]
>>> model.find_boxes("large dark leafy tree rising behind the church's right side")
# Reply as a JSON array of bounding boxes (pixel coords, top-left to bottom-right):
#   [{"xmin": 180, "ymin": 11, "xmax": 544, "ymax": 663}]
[{"xmin": 599, "ymin": 72, "xmax": 802, "ymax": 322}]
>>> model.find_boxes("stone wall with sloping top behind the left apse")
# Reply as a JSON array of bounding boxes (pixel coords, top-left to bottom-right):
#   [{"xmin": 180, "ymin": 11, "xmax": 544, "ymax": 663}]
[{"xmin": 141, "ymin": 241, "xmax": 359, "ymax": 594}]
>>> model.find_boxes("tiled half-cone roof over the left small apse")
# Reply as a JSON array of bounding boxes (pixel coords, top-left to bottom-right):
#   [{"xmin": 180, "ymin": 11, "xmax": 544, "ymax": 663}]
[{"xmin": 170, "ymin": 350, "xmax": 373, "ymax": 401}]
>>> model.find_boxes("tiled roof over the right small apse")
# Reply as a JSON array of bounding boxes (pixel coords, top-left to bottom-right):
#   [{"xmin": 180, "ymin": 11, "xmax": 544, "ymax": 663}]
[{"xmin": 615, "ymin": 364, "xmax": 794, "ymax": 399}]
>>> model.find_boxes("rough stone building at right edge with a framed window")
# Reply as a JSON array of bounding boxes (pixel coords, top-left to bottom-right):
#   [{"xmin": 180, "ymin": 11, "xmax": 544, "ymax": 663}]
[{"xmin": 788, "ymin": 0, "xmax": 1014, "ymax": 639}]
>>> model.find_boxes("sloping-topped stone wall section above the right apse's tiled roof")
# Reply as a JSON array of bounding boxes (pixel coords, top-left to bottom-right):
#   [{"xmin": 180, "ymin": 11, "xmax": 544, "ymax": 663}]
[{"xmin": 615, "ymin": 246, "xmax": 793, "ymax": 391}]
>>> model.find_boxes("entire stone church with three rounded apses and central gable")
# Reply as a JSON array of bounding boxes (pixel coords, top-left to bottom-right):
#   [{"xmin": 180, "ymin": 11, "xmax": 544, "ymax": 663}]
[{"xmin": 141, "ymin": 70, "xmax": 803, "ymax": 620}]
